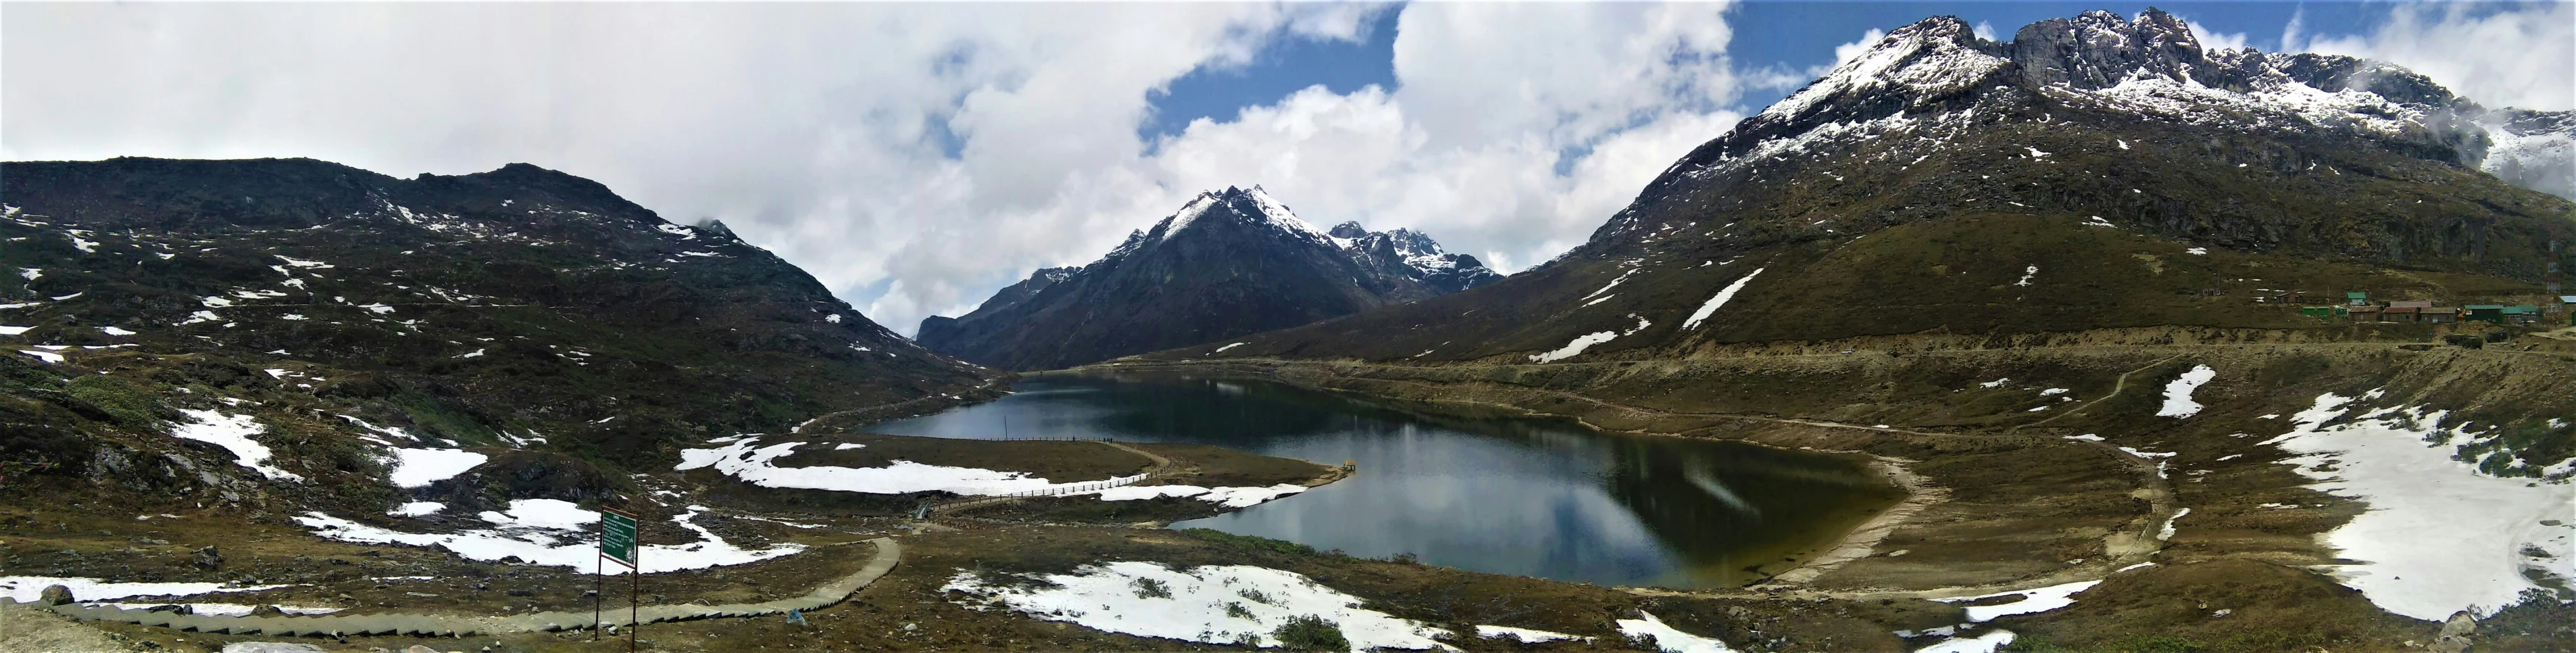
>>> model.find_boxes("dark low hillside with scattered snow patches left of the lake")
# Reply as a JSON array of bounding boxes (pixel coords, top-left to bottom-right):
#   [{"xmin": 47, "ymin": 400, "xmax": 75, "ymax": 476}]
[{"xmin": 0, "ymin": 158, "xmax": 999, "ymax": 511}]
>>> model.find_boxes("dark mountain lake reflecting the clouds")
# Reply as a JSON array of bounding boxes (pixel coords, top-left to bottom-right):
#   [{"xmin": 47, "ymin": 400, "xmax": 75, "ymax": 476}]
[{"xmin": 866, "ymin": 374, "xmax": 1901, "ymax": 589}]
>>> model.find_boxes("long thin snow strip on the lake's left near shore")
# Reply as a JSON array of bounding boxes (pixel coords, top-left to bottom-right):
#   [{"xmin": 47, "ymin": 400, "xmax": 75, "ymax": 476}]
[{"xmin": 672, "ymin": 436, "xmax": 1144, "ymax": 495}]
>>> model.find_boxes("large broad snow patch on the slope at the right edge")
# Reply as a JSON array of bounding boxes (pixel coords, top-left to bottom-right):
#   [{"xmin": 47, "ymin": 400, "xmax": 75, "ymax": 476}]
[{"xmin": 2267, "ymin": 392, "xmax": 2576, "ymax": 619}]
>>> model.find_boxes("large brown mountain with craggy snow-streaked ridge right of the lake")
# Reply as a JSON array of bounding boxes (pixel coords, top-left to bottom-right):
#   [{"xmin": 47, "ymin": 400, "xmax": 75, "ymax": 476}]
[{"xmin": 1170, "ymin": 10, "xmax": 2576, "ymax": 362}]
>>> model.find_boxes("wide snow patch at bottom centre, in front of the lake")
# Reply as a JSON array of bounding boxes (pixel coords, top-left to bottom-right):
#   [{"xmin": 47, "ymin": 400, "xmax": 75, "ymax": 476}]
[{"xmin": 940, "ymin": 562, "xmax": 1450, "ymax": 650}]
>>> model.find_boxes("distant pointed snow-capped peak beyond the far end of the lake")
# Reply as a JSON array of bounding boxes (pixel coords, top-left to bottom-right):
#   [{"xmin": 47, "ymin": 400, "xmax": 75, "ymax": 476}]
[{"xmin": 920, "ymin": 186, "xmax": 1502, "ymax": 369}]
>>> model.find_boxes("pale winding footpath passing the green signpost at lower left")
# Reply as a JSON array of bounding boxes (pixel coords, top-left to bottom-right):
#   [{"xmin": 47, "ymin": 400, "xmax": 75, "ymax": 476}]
[{"xmin": 0, "ymin": 537, "xmax": 904, "ymax": 637}]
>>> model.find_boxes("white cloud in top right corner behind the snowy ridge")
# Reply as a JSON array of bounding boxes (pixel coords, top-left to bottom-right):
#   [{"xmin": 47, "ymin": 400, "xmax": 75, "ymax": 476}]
[{"xmin": 2280, "ymin": 3, "xmax": 2576, "ymax": 111}]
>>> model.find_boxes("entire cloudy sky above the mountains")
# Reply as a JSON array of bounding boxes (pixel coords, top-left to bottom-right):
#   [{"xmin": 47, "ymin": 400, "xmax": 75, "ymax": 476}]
[{"xmin": 15, "ymin": 3, "xmax": 2576, "ymax": 333}]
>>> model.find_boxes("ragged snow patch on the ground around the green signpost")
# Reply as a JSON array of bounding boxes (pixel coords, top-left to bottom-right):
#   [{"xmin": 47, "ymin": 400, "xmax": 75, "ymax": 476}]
[{"xmin": 296, "ymin": 498, "xmax": 806, "ymax": 575}]
